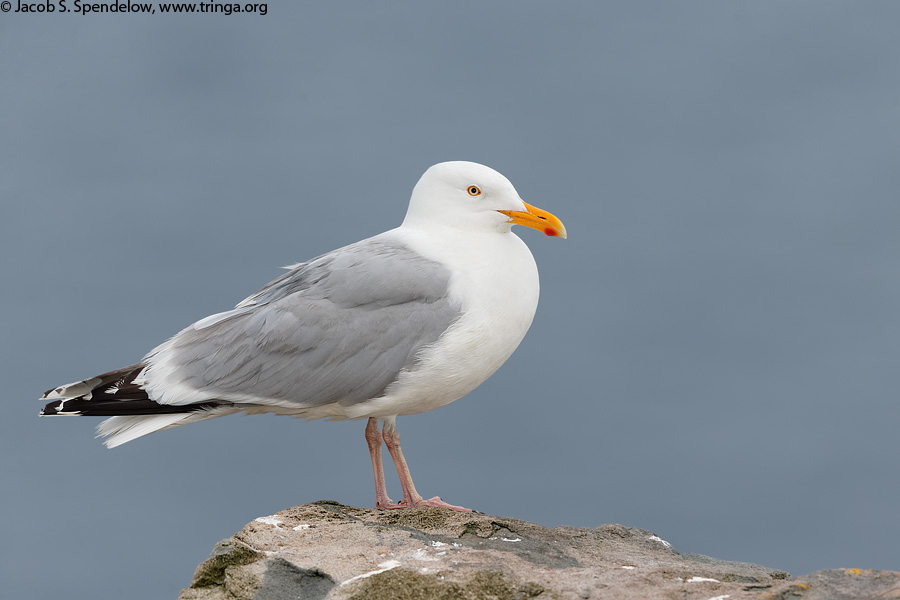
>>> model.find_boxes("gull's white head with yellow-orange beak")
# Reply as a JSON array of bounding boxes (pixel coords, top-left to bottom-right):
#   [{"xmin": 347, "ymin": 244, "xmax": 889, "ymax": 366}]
[{"xmin": 403, "ymin": 161, "xmax": 566, "ymax": 238}]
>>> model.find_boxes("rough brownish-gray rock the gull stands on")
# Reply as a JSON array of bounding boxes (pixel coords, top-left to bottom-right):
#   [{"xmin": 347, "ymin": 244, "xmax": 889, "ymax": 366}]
[{"xmin": 180, "ymin": 501, "xmax": 900, "ymax": 600}]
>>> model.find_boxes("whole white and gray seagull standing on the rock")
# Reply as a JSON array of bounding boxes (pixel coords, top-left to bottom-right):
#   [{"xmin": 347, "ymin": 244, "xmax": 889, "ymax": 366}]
[{"xmin": 40, "ymin": 161, "xmax": 566, "ymax": 512}]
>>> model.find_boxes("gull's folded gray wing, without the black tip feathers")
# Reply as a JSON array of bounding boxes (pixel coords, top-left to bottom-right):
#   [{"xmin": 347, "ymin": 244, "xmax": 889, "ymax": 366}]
[{"xmin": 149, "ymin": 237, "xmax": 460, "ymax": 407}]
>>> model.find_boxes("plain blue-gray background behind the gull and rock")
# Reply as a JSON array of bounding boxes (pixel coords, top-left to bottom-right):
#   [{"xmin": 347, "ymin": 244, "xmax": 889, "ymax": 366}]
[{"xmin": 0, "ymin": 0, "xmax": 900, "ymax": 600}]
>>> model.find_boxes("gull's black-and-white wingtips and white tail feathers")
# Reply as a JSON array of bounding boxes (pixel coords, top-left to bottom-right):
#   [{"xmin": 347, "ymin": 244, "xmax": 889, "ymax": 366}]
[{"xmin": 40, "ymin": 362, "xmax": 237, "ymax": 448}]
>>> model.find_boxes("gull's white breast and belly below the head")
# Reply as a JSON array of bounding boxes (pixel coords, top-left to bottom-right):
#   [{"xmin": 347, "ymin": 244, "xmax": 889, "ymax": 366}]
[{"xmin": 344, "ymin": 227, "xmax": 540, "ymax": 417}]
